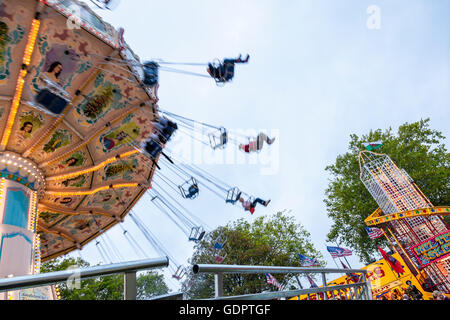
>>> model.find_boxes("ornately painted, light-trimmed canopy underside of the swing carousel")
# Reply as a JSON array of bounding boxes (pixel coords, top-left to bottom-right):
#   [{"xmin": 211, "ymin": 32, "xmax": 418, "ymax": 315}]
[{"xmin": 0, "ymin": 0, "xmax": 157, "ymax": 261}]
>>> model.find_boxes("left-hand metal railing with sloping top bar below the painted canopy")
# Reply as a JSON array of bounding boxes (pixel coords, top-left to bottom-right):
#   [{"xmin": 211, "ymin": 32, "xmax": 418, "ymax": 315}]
[{"xmin": 0, "ymin": 257, "xmax": 169, "ymax": 300}]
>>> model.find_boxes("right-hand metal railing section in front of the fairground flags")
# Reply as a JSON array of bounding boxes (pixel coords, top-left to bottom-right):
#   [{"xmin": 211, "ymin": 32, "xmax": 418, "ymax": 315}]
[{"xmin": 192, "ymin": 264, "xmax": 372, "ymax": 300}]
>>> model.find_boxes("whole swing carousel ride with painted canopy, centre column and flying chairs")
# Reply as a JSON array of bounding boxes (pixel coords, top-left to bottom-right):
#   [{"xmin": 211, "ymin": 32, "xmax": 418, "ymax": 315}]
[{"xmin": 0, "ymin": 0, "xmax": 274, "ymax": 292}]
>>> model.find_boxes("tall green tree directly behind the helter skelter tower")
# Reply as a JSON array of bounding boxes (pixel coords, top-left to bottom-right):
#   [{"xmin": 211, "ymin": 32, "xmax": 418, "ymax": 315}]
[{"xmin": 324, "ymin": 119, "xmax": 450, "ymax": 263}]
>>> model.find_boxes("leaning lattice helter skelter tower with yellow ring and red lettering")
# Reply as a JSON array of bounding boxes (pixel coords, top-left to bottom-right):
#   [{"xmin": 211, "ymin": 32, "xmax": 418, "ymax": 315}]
[{"xmin": 359, "ymin": 151, "xmax": 450, "ymax": 293}]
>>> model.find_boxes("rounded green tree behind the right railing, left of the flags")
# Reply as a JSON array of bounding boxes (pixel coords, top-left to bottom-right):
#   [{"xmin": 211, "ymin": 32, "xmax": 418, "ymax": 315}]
[{"xmin": 183, "ymin": 212, "xmax": 324, "ymax": 299}]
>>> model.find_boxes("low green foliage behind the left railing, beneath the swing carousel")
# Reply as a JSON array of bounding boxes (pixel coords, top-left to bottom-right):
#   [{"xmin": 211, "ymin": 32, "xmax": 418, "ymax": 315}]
[{"xmin": 41, "ymin": 258, "xmax": 169, "ymax": 300}]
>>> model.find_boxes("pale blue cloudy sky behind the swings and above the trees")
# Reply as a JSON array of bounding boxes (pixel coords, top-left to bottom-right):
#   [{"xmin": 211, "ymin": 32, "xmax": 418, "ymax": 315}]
[{"xmin": 68, "ymin": 0, "xmax": 450, "ymax": 290}]
